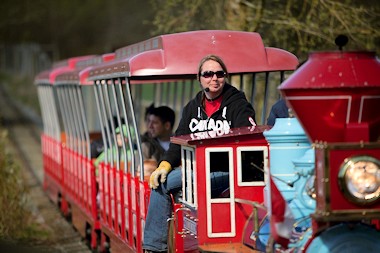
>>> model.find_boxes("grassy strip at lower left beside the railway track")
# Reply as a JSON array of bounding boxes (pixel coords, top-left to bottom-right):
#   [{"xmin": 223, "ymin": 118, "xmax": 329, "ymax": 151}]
[{"xmin": 0, "ymin": 127, "xmax": 50, "ymax": 244}]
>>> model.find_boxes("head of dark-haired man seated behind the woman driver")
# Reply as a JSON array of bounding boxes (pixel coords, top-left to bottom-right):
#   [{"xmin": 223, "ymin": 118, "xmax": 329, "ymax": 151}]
[{"xmin": 148, "ymin": 106, "xmax": 175, "ymax": 139}]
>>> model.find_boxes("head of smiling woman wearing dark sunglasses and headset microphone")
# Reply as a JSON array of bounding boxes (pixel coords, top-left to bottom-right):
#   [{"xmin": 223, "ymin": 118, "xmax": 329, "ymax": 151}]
[{"xmin": 198, "ymin": 55, "xmax": 228, "ymax": 97}]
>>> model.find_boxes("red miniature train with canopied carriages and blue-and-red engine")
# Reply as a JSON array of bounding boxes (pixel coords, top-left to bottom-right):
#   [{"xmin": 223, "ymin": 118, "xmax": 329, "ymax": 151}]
[{"xmin": 35, "ymin": 30, "xmax": 380, "ymax": 252}]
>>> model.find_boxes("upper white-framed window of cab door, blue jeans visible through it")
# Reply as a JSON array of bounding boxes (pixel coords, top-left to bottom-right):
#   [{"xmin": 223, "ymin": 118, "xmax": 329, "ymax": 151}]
[{"xmin": 206, "ymin": 148, "xmax": 233, "ymax": 199}]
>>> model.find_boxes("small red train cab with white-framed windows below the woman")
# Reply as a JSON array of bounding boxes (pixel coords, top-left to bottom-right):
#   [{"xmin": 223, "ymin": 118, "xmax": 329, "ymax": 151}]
[{"xmin": 172, "ymin": 126, "xmax": 270, "ymax": 252}]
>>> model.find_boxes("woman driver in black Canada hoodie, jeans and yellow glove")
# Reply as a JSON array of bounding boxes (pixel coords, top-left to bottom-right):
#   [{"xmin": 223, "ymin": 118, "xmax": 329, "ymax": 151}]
[{"xmin": 143, "ymin": 55, "xmax": 256, "ymax": 252}]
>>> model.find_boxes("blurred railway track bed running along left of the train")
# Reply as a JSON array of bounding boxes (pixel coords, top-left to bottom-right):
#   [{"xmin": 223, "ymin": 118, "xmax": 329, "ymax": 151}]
[{"xmin": 0, "ymin": 84, "xmax": 91, "ymax": 253}]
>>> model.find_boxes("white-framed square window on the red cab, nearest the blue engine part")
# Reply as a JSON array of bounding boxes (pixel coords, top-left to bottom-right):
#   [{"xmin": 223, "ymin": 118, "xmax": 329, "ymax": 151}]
[{"xmin": 237, "ymin": 147, "xmax": 268, "ymax": 186}]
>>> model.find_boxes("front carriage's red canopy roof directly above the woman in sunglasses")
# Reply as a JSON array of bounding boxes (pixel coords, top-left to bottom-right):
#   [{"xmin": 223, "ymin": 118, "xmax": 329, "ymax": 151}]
[{"xmin": 89, "ymin": 30, "xmax": 298, "ymax": 80}]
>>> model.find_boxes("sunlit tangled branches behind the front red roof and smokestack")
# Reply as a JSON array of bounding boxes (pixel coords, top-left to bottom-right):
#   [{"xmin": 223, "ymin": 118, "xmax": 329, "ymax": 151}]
[{"xmin": 152, "ymin": 0, "xmax": 380, "ymax": 61}]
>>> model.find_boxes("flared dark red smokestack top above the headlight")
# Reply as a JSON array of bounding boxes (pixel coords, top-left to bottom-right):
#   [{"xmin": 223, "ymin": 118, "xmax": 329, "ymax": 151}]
[{"xmin": 280, "ymin": 52, "xmax": 380, "ymax": 142}]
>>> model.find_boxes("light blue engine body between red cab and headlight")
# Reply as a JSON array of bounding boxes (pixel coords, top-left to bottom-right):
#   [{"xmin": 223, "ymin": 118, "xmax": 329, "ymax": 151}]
[{"xmin": 260, "ymin": 118, "xmax": 315, "ymax": 248}]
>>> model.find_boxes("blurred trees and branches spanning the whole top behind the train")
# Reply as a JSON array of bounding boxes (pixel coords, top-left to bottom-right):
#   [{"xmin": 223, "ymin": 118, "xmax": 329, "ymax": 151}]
[{"xmin": 0, "ymin": 0, "xmax": 380, "ymax": 60}]
